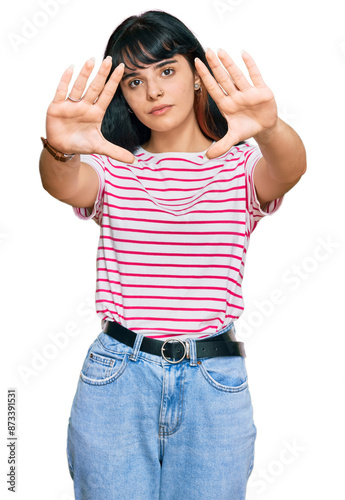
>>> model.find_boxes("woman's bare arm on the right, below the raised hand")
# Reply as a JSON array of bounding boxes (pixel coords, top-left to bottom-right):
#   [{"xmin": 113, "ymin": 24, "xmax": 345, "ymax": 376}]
[{"xmin": 254, "ymin": 118, "xmax": 307, "ymax": 206}]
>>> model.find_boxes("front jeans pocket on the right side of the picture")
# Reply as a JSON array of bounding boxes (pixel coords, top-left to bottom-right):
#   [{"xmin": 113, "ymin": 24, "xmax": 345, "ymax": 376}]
[{"xmin": 199, "ymin": 356, "xmax": 248, "ymax": 392}]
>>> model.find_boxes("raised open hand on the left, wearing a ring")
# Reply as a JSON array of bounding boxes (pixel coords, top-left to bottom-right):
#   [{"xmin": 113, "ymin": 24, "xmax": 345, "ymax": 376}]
[{"xmin": 46, "ymin": 56, "xmax": 134, "ymax": 163}]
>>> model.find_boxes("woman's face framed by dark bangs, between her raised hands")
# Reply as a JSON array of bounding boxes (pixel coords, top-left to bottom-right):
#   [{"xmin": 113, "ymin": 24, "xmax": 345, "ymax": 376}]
[{"xmin": 121, "ymin": 54, "xmax": 200, "ymax": 132}]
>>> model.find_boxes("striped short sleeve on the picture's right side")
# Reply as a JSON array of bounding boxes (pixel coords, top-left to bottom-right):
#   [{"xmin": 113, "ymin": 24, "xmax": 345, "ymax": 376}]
[{"xmin": 244, "ymin": 145, "xmax": 283, "ymax": 232}]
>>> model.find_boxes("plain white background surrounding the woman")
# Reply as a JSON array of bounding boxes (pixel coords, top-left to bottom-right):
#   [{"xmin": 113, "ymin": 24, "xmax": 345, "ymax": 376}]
[{"xmin": 0, "ymin": 0, "xmax": 345, "ymax": 500}]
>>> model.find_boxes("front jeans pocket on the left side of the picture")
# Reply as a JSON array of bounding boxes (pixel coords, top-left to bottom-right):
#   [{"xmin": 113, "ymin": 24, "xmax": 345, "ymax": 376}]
[{"xmin": 80, "ymin": 339, "xmax": 129, "ymax": 385}]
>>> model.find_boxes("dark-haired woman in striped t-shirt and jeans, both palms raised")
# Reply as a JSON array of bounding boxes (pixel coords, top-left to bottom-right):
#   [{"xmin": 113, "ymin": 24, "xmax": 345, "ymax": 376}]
[{"xmin": 40, "ymin": 11, "xmax": 306, "ymax": 500}]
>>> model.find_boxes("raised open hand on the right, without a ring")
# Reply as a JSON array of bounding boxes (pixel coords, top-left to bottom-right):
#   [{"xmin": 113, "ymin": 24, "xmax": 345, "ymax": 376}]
[{"xmin": 195, "ymin": 50, "xmax": 278, "ymax": 159}]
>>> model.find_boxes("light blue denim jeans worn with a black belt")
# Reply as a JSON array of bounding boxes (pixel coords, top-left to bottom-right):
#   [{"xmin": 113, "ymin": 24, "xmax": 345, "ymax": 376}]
[{"xmin": 67, "ymin": 324, "xmax": 256, "ymax": 500}]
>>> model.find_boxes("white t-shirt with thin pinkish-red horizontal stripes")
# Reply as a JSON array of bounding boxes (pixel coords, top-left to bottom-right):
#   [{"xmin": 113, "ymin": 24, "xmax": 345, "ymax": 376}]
[{"xmin": 74, "ymin": 142, "xmax": 282, "ymax": 340}]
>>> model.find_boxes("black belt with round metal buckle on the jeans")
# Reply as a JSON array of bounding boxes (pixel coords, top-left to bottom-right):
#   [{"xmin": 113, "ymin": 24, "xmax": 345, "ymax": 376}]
[{"xmin": 103, "ymin": 321, "xmax": 246, "ymax": 363}]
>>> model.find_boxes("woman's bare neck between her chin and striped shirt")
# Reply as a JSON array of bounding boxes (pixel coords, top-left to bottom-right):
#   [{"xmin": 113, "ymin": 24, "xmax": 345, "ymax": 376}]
[{"xmin": 142, "ymin": 113, "xmax": 213, "ymax": 154}]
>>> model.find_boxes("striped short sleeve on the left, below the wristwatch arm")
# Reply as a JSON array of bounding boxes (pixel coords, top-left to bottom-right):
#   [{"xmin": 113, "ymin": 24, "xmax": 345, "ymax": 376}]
[{"xmin": 73, "ymin": 151, "xmax": 105, "ymax": 224}]
